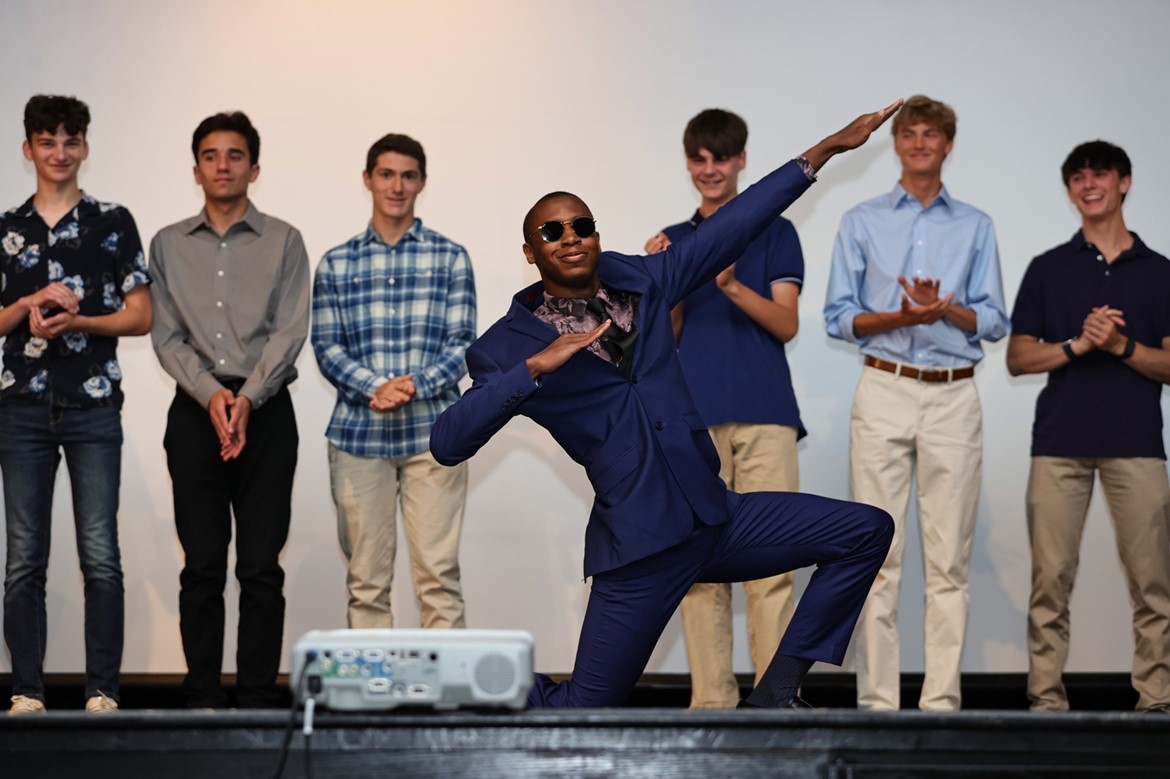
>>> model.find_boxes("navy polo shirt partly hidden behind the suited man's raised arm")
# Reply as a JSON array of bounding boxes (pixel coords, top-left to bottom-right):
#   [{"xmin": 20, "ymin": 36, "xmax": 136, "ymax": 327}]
[{"xmin": 663, "ymin": 211, "xmax": 805, "ymax": 439}]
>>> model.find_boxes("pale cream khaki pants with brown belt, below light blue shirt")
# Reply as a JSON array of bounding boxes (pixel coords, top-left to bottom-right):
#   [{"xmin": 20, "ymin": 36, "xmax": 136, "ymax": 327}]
[{"xmin": 849, "ymin": 367, "xmax": 983, "ymax": 710}]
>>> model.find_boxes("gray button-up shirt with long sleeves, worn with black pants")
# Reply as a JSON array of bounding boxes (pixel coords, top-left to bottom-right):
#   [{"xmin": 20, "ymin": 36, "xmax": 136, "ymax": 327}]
[{"xmin": 150, "ymin": 201, "xmax": 309, "ymax": 408}]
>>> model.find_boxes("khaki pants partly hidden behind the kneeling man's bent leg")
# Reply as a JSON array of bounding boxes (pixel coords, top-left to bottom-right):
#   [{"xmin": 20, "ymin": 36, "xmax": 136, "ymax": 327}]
[{"xmin": 680, "ymin": 423, "xmax": 800, "ymax": 709}]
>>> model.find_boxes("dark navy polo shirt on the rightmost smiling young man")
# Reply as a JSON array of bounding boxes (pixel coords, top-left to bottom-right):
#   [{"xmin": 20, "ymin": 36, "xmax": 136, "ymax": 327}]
[{"xmin": 1012, "ymin": 232, "xmax": 1170, "ymax": 460}]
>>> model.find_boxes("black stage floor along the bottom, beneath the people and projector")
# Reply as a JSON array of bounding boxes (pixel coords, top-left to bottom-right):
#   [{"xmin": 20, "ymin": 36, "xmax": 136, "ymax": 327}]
[{"xmin": 0, "ymin": 674, "xmax": 1170, "ymax": 779}]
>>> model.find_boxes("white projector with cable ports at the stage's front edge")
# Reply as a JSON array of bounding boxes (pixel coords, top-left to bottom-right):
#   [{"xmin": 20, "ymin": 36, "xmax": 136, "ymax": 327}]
[{"xmin": 289, "ymin": 629, "xmax": 532, "ymax": 711}]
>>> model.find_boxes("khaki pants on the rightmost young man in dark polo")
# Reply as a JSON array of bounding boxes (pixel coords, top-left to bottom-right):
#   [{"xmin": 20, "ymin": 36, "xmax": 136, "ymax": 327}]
[{"xmin": 1027, "ymin": 457, "xmax": 1170, "ymax": 711}]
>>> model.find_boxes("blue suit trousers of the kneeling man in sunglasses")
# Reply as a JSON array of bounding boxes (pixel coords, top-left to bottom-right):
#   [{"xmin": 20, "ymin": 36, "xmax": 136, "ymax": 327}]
[{"xmin": 529, "ymin": 492, "xmax": 894, "ymax": 708}]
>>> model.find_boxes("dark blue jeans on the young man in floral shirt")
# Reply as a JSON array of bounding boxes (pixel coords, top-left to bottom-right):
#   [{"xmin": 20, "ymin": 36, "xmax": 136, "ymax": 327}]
[{"xmin": 0, "ymin": 404, "xmax": 124, "ymax": 701}]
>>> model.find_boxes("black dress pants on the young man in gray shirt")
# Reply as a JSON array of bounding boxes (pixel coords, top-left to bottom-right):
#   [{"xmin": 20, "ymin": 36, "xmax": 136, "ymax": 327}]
[{"xmin": 164, "ymin": 387, "xmax": 298, "ymax": 708}]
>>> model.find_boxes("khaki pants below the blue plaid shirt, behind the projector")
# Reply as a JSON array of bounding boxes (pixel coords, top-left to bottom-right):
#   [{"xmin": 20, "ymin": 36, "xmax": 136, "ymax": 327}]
[{"xmin": 329, "ymin": 444, "xmax": 467, "ymax": 628}]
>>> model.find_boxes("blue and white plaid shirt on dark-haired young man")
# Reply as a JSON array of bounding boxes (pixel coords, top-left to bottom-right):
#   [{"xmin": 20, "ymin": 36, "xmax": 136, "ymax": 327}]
[{"xmin": 311, "ymin": 219, "xmax": 475, "ymax": 459}]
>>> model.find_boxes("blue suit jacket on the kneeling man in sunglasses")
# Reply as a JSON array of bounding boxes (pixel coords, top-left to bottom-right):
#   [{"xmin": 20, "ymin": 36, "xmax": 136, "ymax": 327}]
[{"xmin": 431, "ymin": 163, "xmax": 810, "ymax": 577}]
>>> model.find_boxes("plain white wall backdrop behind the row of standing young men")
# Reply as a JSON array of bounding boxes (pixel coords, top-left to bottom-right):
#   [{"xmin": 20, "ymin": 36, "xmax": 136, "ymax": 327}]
[{"xmin": 0, "ymin": 0, "xmax": 1170, "ymax": 673}]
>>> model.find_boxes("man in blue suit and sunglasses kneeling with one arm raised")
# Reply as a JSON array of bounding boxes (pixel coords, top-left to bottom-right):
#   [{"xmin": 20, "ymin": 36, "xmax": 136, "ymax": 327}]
[{"xmin": 431, "ymin": 101, "xmax": 901, "ymax": 708}]
